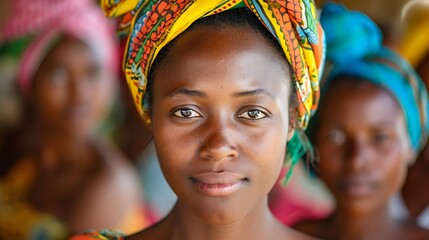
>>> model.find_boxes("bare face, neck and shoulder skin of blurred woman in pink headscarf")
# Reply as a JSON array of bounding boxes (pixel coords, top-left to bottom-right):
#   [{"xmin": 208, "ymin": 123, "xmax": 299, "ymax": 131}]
[{"xmin": 24, "ymin": 38, "xmax": 141, "ymax": 232}]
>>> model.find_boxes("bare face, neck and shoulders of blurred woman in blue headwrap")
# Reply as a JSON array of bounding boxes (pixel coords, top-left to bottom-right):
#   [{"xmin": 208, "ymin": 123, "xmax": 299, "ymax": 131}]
[{"xmin": 295, "ymin": 77, "xmax": 429, "ymax": 240}]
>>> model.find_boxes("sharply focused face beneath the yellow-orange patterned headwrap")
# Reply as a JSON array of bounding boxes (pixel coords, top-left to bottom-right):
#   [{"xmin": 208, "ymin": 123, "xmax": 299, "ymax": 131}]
[{"xmin": 152, "ymin": 27, "xmax": 293, "ymax": 224}]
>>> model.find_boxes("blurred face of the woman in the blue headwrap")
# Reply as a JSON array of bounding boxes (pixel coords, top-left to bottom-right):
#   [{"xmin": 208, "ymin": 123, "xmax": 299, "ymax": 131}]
[{"xmin": 315, "ymin": 79, "xmax": 413, "ymax": 214}]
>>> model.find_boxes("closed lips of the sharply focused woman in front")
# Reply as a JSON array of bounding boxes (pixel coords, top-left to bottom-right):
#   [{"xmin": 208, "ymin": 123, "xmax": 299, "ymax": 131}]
[{"xmin": 190, "ymin": 172, "xmax": 248, "ymax": 197}]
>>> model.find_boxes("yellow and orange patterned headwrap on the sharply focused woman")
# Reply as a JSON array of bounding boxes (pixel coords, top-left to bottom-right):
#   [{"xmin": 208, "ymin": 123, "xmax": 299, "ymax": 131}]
[{"xmin": 102, "ymin": 0, "xmax": 324, "ymax": 129}]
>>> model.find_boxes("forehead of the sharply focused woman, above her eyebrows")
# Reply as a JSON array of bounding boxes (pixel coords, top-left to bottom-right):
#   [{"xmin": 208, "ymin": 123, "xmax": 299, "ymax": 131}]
[{"xmin": 155, "ymin": 27, "xmax": 291, "ymax": 94}]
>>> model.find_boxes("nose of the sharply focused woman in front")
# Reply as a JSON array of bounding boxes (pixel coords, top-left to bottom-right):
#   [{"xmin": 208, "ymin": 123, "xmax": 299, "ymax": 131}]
[{"xmin": 200, "ymin": 122, "xmax": 239, "ymax": 161}]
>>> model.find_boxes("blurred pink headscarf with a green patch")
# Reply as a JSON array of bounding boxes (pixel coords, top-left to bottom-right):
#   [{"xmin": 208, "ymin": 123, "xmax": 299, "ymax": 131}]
[{"xmin": 0, "ymin": 0, "xmax": 117, "ymax": 92}]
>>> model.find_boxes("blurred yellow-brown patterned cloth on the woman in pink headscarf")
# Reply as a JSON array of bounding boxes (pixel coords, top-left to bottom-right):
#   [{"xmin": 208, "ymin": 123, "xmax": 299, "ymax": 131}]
[{"xmin": 0, "ymin": 158, "xmax": 69, "ymax": 240}]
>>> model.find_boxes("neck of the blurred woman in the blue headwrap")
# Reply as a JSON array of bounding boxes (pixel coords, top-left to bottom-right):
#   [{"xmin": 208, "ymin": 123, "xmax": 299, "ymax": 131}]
[{"xmin": 328, "ymin": 204, "xmax": 398, "ymax": 240}]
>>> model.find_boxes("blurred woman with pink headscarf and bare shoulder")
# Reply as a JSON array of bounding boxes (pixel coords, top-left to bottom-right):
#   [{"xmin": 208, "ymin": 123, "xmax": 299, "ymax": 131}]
[{"xmin": 0, "ymin": 0, "xmax": 149, "ymax": 239}]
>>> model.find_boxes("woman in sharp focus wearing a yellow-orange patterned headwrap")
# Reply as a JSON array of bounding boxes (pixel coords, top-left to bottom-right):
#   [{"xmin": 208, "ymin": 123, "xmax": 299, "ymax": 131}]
[{"xmin": 73, "ymin": 0, "xmax": 323, "ymax": 240}]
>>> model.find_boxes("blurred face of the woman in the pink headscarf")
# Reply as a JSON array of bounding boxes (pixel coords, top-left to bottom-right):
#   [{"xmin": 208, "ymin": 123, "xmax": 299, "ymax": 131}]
[{"xmin": 32, "ymin": 39, "xmax": 114, "ymax": 136}]
